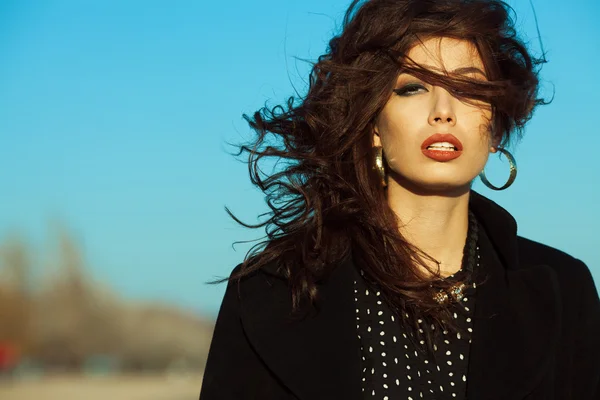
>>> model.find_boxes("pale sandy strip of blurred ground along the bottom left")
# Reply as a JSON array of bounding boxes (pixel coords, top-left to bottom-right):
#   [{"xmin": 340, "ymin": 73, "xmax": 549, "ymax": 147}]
[{"xmin": 0, "ymin": 374, "xmax": 202, "ymax": 400}]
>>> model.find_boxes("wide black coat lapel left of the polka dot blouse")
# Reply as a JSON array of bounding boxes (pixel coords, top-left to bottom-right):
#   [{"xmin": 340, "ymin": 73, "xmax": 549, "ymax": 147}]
[{"xmin": 241, "ymin": 255, "xmax": 361, "ymax": 400}]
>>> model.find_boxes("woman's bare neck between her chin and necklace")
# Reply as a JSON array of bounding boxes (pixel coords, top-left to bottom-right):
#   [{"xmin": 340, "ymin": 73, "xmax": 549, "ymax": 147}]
[{"xmin": 387, "ymin": 180, "xmax": 470, "ymax": 277}]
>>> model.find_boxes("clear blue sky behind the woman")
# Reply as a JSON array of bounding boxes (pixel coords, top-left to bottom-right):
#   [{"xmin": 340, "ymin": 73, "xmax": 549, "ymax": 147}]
[{"xmin": 0, "ymin": 0, "xmax": 600, "ymax": 315}]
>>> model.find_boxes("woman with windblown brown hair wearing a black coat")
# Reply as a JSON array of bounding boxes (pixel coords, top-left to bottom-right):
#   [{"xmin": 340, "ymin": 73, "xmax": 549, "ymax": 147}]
[{"xmin": 201, "ymin": 0, "xmax": 600, "ymax": 400}]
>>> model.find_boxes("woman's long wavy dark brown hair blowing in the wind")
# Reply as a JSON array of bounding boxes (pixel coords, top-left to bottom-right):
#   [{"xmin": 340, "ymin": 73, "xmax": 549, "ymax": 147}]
[{"xmin": 227, "ymin": 0, "xmax": 545, "ymax": 350}]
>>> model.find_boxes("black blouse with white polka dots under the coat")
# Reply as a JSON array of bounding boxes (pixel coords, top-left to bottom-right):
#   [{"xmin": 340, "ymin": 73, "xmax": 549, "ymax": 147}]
[{"xmin": 354, "ymin": 271, "xmax": 475, "ymax": 400}]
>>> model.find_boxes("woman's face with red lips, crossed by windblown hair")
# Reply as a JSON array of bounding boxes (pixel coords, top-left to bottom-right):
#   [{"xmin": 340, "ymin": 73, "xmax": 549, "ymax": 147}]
[{"xmin": 374, "ymin": 38, "xmax": 492, "ymax": 192}]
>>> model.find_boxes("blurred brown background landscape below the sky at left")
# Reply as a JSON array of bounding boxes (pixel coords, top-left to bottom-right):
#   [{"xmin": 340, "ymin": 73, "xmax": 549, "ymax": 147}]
[{"xmin": 0, "ymin": 231, "xmax": 214, "ymax": 386}]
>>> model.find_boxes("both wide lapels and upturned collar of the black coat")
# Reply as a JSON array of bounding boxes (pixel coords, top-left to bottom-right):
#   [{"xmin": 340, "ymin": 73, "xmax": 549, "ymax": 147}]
[{"xmin": 241, "ymin": 192, "xmax": 560, "ymax": 400}]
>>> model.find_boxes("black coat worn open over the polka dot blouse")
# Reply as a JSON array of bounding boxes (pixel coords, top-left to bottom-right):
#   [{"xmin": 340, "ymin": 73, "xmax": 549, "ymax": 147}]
[{"xmin": 200, "ymin": 192, "xmax": 600, "ymax": 400}]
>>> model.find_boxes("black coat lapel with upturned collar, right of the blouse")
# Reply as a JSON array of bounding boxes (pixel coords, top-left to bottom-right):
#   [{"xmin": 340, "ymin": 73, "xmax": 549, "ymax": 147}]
[{"xmin": 467, "ymin": 193, "xmax": 561, "ymax": 400}]
